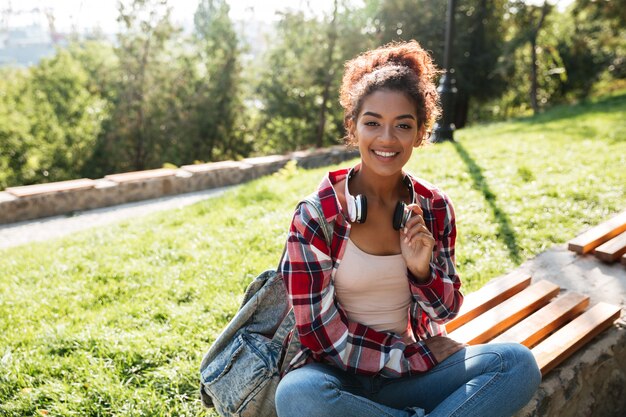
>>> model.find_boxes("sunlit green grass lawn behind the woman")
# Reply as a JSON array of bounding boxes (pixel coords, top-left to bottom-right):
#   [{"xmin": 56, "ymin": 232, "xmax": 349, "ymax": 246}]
[{"xmin": 0, "ymin": 94, "xmax": 626, "ymax": 416}]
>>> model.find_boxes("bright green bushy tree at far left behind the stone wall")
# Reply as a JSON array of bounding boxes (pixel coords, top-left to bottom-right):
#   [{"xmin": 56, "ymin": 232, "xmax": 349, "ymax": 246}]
[{"xmin": 0, "ymin": 50, "xmax": 106, "ymax": 186}]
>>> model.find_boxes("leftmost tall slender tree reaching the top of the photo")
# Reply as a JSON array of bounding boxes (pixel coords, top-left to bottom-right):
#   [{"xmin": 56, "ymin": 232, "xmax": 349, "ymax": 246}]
[{"xmin": 106, "ymin": 0, "xmax": 178, "ymax": 170}]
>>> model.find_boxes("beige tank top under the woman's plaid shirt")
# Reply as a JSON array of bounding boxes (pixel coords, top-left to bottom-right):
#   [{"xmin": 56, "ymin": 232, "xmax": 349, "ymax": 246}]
[{"xmin": 335, "ymin": 239, "xmax": 415, "ymax": 343}]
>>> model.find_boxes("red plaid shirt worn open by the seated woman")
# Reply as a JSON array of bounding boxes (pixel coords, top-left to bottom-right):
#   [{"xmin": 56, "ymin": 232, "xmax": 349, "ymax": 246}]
[{"xmin": 280, "ymin": 169, "xmax": 463, "ymax": 377}]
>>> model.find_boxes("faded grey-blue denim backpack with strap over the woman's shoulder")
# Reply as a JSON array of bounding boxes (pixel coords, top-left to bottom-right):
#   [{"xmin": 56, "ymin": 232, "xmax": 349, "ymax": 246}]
[{"xmin": 200, "ymin": 193, "xmax": 333, "ymax": 417}]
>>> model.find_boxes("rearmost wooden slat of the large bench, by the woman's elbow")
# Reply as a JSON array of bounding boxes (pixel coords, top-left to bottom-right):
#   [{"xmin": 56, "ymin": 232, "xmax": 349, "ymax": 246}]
[{"xmin": 446, "ymin": 271, "xmax": 531, "ymax": 332}]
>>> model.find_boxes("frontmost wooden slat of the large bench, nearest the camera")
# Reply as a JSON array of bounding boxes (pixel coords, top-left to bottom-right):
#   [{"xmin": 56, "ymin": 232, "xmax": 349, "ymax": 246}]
[{"xmin": 531, "ymin": 302, "xmax": 621, "ymax": 375}]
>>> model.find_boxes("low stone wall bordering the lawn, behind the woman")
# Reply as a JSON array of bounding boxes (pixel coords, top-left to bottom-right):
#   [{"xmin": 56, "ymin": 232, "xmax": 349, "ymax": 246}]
[{"xmin": 0, "ymin": 146, "xmax": 358, "ymax": 224}]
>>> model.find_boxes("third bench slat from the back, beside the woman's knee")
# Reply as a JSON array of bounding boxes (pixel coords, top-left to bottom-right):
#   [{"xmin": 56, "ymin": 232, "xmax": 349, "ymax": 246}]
[{"xmin": 490, "ymin": 292, "xmax": 589, "ymax": 348}]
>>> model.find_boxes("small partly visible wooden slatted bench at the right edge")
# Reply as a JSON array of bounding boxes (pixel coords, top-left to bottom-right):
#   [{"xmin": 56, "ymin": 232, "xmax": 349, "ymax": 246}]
[{"xmin": 567, "ymin": 210, "xmax": 626, "ymax": 263}]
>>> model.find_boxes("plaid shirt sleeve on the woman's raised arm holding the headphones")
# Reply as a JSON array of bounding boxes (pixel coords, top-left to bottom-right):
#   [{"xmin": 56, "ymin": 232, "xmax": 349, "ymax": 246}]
[{"xmin": 407, "ymin": 193, "xmax": 463, "ymax": 324}]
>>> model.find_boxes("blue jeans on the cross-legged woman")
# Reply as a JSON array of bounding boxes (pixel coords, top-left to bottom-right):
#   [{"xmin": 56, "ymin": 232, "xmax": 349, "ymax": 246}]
[{"xmin": 276, "ymin": 343, "xmax": 541, "ymax": 417}]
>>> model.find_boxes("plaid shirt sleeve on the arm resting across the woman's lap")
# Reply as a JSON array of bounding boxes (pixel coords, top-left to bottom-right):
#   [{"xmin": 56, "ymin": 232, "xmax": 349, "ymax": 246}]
[{"xmin": 281, "ymin": 204, "xmax": 437, "ymax": 377}]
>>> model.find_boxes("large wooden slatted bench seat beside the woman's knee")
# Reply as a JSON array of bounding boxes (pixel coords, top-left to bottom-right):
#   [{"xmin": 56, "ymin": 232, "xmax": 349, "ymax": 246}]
[{"xmin": 446, "ymin": 272, "xmax": 621, "ymax": 375}]
